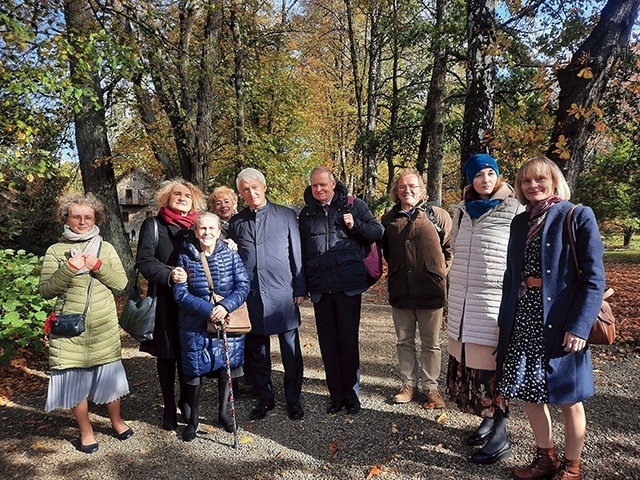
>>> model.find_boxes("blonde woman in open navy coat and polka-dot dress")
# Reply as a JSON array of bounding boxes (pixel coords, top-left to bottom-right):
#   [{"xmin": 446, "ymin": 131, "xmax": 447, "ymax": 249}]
[{"xmin": 497, "ymin": 157, "xmax": 605, "ymax": 480}]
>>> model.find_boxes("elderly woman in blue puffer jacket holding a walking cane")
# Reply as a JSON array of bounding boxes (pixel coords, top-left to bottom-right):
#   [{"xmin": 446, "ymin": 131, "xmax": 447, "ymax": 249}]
[{"xmin": 173, "ymin": 212, "xmax": 249, "ymax": 442}]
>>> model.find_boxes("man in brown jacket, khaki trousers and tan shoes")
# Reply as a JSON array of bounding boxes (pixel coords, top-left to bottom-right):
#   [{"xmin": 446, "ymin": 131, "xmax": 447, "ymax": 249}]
[{"xmin": 382, "ymin": 170, "xmax": 453, "ymax": 408}]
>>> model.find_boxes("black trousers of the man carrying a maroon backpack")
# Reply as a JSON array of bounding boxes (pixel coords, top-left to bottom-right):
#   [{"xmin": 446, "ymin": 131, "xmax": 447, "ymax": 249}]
[{"xmin": 313, "ymin": 292, "xmax": 362, "ymax": 403}]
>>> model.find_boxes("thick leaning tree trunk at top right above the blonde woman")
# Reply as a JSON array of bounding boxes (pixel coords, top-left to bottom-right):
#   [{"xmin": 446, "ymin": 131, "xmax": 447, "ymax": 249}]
[{"xmin": 547, "ymin": 0, "xmax": 640, "ymax": 188}]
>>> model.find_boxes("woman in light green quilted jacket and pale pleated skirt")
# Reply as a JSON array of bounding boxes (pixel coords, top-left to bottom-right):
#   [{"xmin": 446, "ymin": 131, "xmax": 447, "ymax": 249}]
[{"xmin": 38, "ymin": 193, "xmax": 133, "ymax": 453}]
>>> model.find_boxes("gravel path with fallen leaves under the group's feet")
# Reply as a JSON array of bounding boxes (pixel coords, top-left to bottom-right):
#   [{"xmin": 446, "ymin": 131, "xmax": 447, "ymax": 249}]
[{"xmin": 0, "ymin": 298, "xmax": 640, "ymax": 480}]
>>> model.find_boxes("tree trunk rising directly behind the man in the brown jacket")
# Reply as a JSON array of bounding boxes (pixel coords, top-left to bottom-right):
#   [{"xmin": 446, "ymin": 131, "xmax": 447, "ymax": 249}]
[{"xmin": 416, "ymin": 0, "xmax": 448, "ymax": 205}]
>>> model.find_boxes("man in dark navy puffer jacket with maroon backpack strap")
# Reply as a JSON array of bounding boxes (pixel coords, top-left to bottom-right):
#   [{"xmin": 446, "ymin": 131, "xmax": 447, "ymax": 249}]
[{"xmin": 299, "ymin": 166, "xmax": 384, "ymax": 414}]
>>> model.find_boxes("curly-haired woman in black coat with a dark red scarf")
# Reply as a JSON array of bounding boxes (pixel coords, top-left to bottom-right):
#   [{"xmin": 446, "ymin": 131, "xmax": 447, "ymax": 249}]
[{"xmin": 136, "ymin": 179, "xmax": 207, "ymax": 430}]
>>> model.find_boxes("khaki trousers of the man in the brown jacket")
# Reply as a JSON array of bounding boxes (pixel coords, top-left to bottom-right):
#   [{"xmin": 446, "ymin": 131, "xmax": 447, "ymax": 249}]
[{"xmin": 393, "ymin": 308, "xmax": 442, "ymax": 392}]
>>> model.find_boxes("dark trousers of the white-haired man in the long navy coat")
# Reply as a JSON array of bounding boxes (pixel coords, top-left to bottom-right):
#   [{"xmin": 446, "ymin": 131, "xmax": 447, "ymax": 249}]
[{"xmin": 244, "ymin": 328, "xmax": 303, "ymax": 404}]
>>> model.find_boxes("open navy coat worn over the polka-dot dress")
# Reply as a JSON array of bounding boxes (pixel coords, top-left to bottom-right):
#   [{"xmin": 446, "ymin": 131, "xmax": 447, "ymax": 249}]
[{"xmin": 497, "ymin": 201, "xmax": 605, "ymax": 403}]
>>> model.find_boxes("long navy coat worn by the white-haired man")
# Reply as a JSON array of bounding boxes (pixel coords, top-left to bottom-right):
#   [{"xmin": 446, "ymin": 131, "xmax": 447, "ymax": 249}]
[{"xmin": 229, "ymin": 202, "xmax": 307, "ymax": 335}]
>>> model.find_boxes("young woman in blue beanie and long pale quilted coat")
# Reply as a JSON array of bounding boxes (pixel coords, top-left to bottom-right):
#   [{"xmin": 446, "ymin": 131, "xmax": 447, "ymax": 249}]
[{"xmin": 447, "ymin": 153, "xmax": 522, "ymax": 464}]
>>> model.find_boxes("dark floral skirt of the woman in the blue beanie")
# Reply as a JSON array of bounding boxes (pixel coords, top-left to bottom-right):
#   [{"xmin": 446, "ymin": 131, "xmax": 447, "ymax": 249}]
[{"xmin": 447, "ymin": 348, "xmax": 509, "ymax": 418}]
